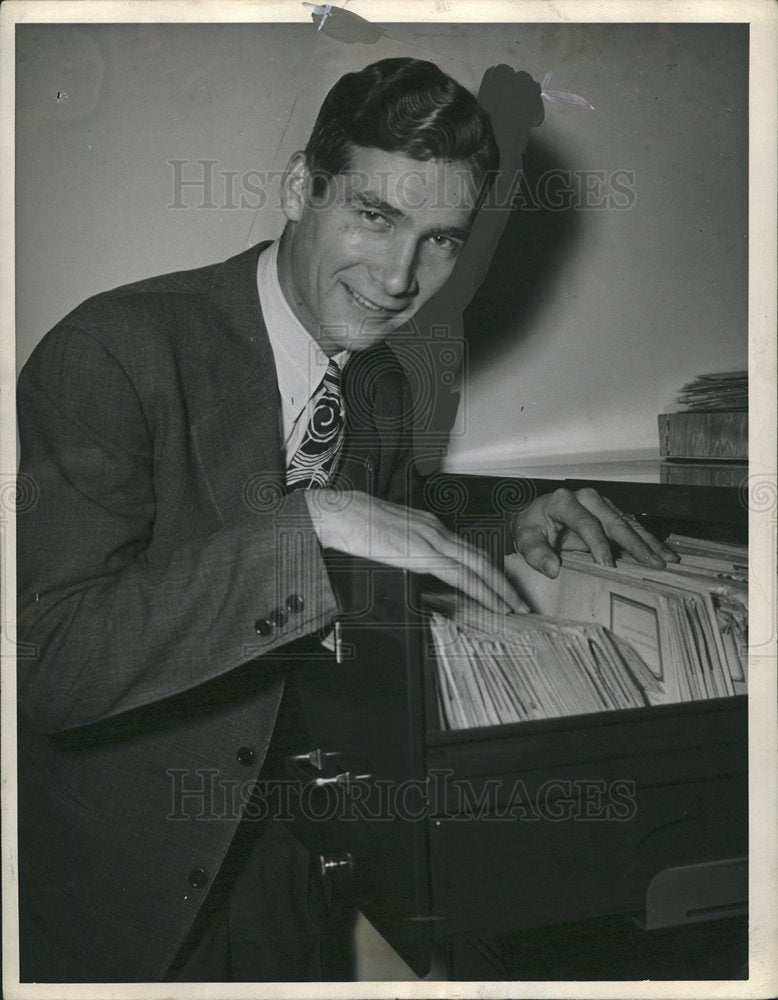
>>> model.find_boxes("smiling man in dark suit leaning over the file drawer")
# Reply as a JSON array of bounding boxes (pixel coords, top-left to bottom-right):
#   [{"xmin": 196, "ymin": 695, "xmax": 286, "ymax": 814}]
[{"xmin": 18, "ymin": 59, "xmax": 672, "ymax": 982}]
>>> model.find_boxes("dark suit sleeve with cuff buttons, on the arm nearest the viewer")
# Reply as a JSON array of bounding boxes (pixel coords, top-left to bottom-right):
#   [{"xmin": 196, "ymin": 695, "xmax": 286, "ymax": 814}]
[{"xmin": 17, "ymin": 334, "xmax": 337, "ymax": 732}]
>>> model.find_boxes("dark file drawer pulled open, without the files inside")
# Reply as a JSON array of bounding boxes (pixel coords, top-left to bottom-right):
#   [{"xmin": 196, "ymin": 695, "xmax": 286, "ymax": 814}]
[{"xmin": 278, "ymin": 563, "xmax": 748, "ymax": 975}]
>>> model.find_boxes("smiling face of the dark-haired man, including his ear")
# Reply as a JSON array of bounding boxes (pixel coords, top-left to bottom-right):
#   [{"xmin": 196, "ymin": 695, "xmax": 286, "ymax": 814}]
[{"xmin": 279, "ymin": 147, "xmax": 478, "ymax": 354}]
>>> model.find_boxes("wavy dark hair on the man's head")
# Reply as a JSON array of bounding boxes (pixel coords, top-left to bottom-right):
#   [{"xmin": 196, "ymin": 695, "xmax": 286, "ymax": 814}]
[{"xmin": 305, "ymin": 59, "xmax": 500, "ymax": 194}]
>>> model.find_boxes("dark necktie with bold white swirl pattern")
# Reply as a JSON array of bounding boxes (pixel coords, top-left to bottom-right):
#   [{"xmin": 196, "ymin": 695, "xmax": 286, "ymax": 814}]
[{"xmin": 286, "ymin": 360, "xmax": 345, "ymax": 490}]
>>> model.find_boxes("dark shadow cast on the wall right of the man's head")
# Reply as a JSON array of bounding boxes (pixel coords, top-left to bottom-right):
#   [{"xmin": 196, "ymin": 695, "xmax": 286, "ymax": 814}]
[{"xmin": 464, "ymin": 136, "xmax": 581, "ymax": 374}]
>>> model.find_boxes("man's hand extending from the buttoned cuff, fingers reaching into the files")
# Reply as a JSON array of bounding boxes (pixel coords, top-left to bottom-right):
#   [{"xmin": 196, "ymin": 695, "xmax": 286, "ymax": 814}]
[{"xmin": 305, "ymin": 489, "xmax": 528, "ymax": 613}]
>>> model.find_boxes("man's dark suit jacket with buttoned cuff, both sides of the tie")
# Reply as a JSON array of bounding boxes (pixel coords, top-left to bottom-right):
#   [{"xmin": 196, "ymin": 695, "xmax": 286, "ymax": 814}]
[{"xmin": 17, "ymin": 240, "xmax": 422, "ymax": 982}]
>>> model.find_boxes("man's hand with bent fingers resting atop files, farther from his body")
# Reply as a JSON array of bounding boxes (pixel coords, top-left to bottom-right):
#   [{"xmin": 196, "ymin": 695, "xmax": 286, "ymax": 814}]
[{"xmin": 510, "ymin": 489, "xmax": 679, "ymax": 579}]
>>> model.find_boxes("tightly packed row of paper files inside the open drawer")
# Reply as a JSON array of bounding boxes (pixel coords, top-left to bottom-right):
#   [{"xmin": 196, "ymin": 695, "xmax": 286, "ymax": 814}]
[{"xmin": 425, "ymin": 535, "xmax": 748, "ymax": 729}]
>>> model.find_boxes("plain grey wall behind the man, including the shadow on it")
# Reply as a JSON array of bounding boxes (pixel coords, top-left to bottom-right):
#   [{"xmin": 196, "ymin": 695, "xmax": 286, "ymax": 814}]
[{"xmin": 16, "ymin": 24, "xmax": 748, "ymax": 471}]
